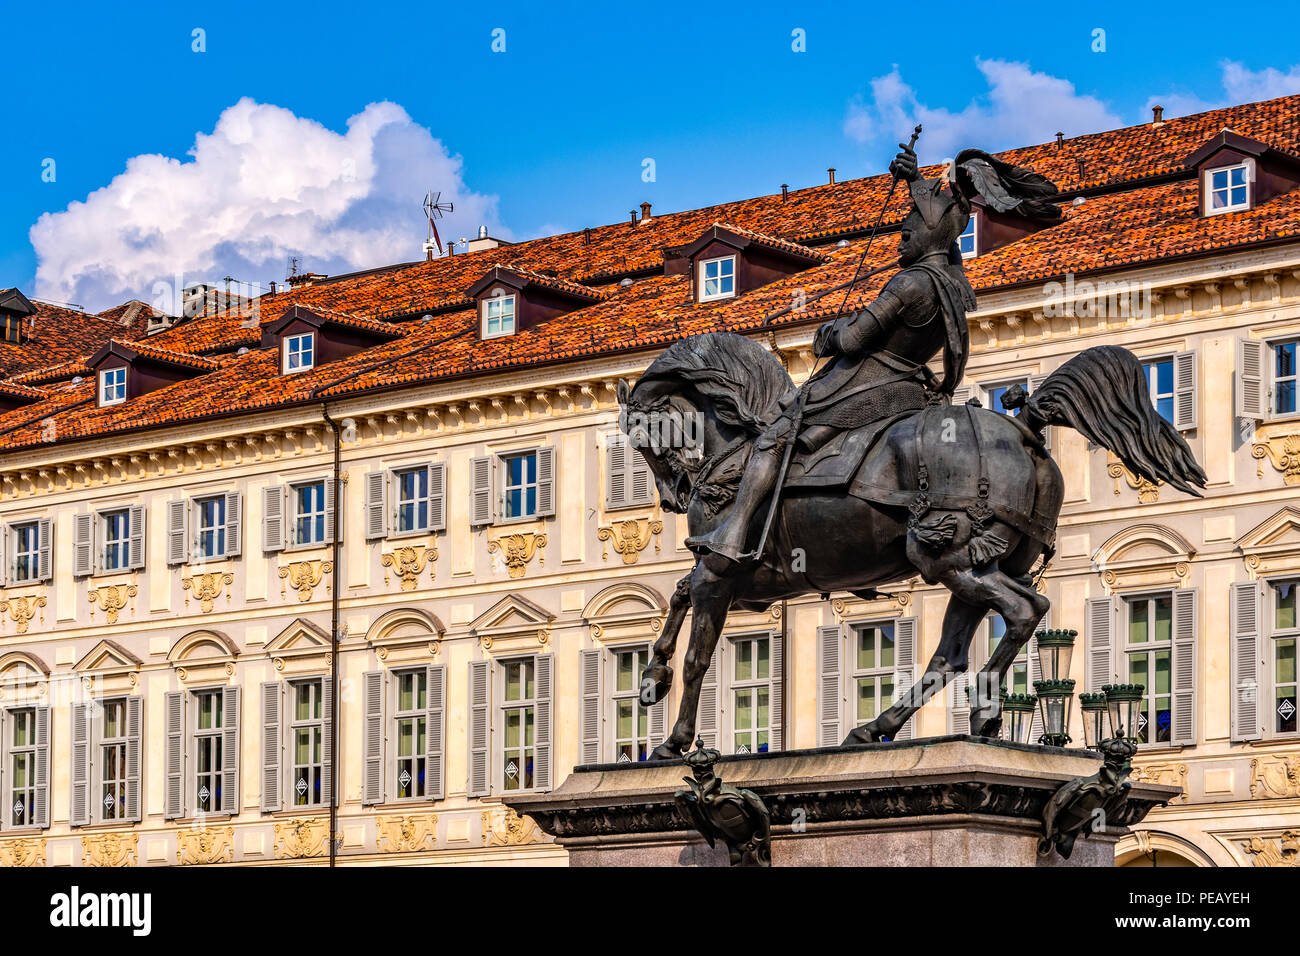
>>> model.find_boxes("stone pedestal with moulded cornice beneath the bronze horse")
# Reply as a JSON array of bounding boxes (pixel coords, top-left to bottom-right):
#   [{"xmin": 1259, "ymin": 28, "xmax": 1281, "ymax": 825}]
[{"xmin": 506, "ymin": 736, "xmax": 1180, "ymax": 866}]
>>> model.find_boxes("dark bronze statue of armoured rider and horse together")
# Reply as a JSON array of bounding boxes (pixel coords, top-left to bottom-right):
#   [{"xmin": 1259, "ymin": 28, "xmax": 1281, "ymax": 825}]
[{"xmin": 619, "ymin": 136, "xmax": 1205, "ymax": 758}]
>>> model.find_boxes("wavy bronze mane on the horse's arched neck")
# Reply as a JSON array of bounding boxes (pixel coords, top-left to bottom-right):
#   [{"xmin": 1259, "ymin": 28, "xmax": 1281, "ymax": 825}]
[{"xmin": 631, "ymin": 332, "xmax": 794, "ymax": 434}]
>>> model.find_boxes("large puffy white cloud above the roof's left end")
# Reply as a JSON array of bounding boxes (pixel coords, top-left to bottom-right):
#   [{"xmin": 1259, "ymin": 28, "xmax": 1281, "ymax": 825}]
[{"xmin": 31, "ymin": 98, "xmax": 496, "ymax": 308}]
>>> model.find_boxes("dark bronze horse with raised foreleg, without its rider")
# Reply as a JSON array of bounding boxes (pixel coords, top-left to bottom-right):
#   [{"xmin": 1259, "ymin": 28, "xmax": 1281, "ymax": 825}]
[{"xmin": 619, "ymin": 333, "xmax": 1205, "ymax": 758}]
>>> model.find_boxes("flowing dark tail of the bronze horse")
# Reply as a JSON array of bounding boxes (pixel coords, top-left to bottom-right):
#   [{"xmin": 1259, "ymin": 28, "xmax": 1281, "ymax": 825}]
[{"xmin": 1002, "ymin": 345, "xmax": 1205, "ymax": 497}]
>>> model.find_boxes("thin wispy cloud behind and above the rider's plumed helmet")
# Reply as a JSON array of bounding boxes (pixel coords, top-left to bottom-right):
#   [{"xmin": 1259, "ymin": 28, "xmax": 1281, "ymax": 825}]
[{"xmin": 844, "ymin": 57, "xmax": 1123, "ymax": 163}]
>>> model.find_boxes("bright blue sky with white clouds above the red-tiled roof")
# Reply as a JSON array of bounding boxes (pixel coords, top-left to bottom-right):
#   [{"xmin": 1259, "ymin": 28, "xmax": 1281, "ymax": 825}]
[{"xmin": 0, "ymin": 3, "xmax": 1300, "ymax": 308}]
